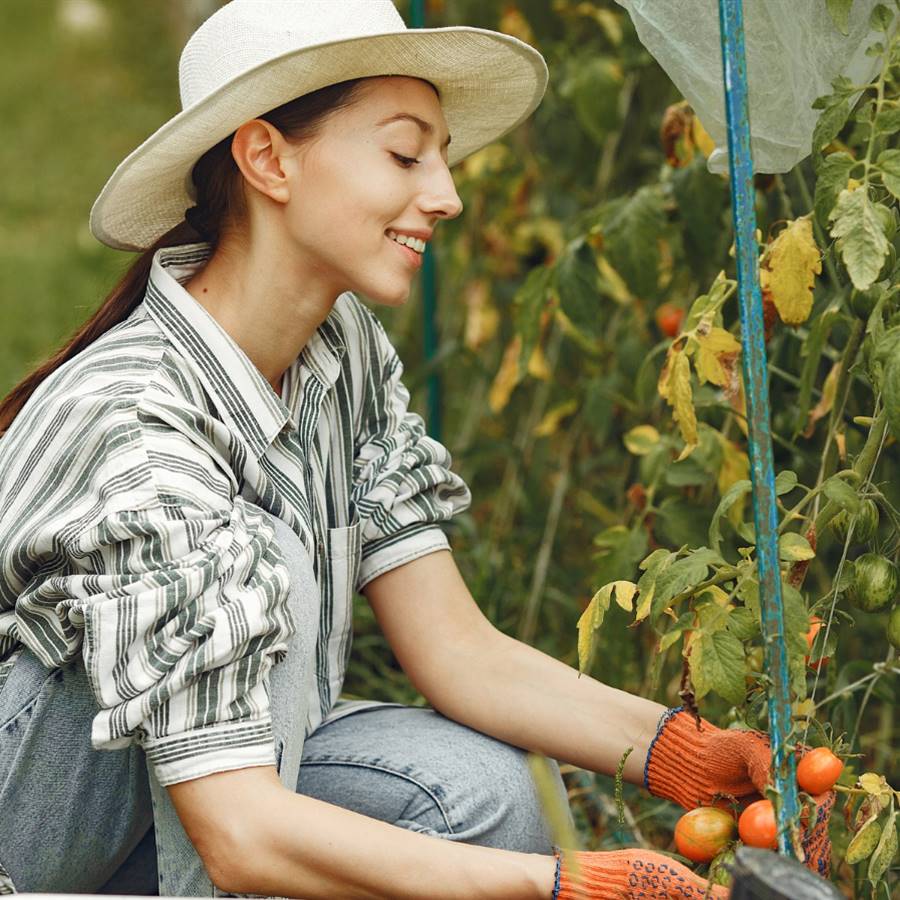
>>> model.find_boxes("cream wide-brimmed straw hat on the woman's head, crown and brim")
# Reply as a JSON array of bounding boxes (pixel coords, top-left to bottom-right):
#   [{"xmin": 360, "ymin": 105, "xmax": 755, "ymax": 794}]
[{"xmin": 90, "ymin": 0, "xmax": 548, "ymax": 250}]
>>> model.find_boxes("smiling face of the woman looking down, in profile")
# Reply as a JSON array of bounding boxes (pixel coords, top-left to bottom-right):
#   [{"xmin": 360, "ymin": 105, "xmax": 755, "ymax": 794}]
[{"xmin": 284, "ymin": 76, "xmax": 462, "ymax": 306}]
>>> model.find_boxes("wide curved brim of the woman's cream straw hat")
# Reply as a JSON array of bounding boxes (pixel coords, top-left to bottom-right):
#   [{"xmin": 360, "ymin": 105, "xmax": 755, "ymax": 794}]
[{"xmin": 90, "ymin": 26, "xmax": 548, "ymax": 251}]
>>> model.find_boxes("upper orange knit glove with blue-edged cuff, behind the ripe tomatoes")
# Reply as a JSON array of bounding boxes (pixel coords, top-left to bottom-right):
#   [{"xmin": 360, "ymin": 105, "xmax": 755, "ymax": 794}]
[{"xmin": 644, "ymin": 706, "xmax": 836, "ymax": 877}]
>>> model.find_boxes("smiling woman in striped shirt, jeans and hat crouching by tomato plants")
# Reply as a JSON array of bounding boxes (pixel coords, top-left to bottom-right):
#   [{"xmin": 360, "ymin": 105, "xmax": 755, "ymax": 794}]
[{"xmin": 0, "ymin": 0, "xmax": 830, "ymax": 898}]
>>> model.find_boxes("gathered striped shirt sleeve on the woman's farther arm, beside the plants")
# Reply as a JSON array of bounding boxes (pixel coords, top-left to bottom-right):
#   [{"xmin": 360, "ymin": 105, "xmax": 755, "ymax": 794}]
[{"xmin": 352, "ymin": 321, "xmax": 472, "ymax": 591}]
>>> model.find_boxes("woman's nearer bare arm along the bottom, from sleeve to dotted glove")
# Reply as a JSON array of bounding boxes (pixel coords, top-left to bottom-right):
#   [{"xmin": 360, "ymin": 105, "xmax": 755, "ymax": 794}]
[{"xmin": 167, "ymin": 766, "xmax": 556, "ymax": 900}]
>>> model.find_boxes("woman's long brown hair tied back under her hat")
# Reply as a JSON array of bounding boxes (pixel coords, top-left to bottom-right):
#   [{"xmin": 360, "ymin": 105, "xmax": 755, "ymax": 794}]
[{"xmin": 0, "ymin": 78, "xmax": 367, "ymax": 436}]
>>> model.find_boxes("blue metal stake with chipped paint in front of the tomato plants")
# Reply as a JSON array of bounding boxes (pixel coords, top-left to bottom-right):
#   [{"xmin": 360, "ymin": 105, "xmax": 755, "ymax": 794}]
[{"xmin": 719, "ymin": 0, "xmax": 798, "ymax": 856}]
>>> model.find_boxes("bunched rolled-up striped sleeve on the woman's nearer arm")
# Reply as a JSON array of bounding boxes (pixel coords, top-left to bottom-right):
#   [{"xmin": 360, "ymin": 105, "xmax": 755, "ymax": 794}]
[{"xmin": 39, "ymin": 497, "xmax": 294, "ymax": 785}]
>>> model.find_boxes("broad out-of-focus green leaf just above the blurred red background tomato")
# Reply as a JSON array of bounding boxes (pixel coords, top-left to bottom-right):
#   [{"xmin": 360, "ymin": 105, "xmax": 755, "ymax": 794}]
[{"xmin": 603, "ymin": 186, "xmax": 665, "ymax": 299}]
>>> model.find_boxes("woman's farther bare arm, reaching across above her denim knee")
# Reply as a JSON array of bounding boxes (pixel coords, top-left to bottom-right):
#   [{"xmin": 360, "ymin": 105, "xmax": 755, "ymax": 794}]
[{"xmin": 364, "ymin": 551, "xmax": 666, "ymax": 784}]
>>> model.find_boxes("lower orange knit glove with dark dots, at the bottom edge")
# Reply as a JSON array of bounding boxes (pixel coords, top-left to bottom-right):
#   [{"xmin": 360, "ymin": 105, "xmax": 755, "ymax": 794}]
[{"xmin": 553, "ymin": 850, "xmax": 728, "ymax": 900}]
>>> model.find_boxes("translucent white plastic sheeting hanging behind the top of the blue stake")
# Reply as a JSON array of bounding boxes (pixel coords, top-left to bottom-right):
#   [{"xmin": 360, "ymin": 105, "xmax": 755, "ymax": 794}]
[{"xmin": 616, "ymin": 0, "xmax": 884, "ymax": 173}]
